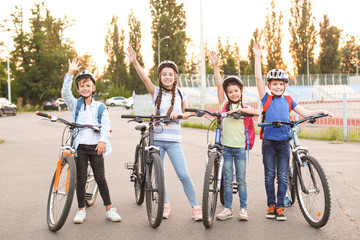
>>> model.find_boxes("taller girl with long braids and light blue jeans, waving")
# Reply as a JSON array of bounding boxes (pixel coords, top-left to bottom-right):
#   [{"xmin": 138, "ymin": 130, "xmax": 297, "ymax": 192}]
[{"xmin": 127, "ymin": 46, "xmax": 202, "ymax": 221}]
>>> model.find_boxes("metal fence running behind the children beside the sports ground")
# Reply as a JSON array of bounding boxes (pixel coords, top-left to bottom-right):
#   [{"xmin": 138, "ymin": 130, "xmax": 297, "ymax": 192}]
[{"xmin": 134, "ymin": 74, "xmax": 360, "ymax": 141}]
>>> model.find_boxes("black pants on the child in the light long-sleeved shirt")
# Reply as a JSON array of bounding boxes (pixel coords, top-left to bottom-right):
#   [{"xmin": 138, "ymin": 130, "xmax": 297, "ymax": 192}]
[{"xmin": 76, "ymin": 144, "xmax": 111, "ymax": 208}]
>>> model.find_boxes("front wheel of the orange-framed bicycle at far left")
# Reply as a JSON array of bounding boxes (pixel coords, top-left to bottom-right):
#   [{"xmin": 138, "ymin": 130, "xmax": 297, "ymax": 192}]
[{"xmin": 47, "ymin": 155, "xmax": 76, "ymax": 232}]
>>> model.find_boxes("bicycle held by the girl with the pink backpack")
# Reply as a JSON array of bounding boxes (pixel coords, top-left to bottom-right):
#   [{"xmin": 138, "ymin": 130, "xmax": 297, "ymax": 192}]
[{"xmin": 185, "ymin": 108, "xmax": 254, "ymax": 228}]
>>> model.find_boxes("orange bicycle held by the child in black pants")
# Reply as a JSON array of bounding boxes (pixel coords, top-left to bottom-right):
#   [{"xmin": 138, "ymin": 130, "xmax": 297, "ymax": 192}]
[{"xmin": 36, "ymin": 112, "xmax": 100, "ymax": 232}]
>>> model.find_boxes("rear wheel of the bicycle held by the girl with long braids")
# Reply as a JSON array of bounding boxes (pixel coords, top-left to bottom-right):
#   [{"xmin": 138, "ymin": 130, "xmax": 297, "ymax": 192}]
[{"xmin": 133, "ymin": 144, "xmax": 145, "ymax": 205}]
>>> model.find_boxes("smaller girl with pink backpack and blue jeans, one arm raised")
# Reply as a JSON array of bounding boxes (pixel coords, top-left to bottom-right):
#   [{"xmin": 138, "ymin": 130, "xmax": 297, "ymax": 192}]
[{"xmin": 210, "ymin": 51, "xmax": 260, "ymax": 221}]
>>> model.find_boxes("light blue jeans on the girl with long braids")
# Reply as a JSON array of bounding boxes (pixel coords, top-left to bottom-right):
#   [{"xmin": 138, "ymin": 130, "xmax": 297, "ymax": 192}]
[{"xmin": 154, "ymin": 141, "xmax": 198, "ymax": 207}]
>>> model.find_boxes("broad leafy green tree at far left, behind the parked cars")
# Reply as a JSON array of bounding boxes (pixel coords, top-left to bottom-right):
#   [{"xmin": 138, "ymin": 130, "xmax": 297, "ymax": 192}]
[{"xmin": 6, "ymin": 2, "xmax": 76, "ymax": 105}]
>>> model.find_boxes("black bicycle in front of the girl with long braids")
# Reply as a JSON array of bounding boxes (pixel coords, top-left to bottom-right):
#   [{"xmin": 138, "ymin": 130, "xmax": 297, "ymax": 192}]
[{"xmin": 121, "ymin": 115, "xmax": 179, "ymax": 228}]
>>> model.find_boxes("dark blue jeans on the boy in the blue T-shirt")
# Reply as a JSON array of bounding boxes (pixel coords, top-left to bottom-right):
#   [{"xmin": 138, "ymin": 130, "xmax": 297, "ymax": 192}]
[{"xmin": 262, "ymin": 139, "xmax": 290, "ymax": 209}]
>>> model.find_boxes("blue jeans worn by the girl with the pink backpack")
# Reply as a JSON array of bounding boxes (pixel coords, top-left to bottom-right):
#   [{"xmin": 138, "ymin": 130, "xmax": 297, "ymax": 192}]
[{"xmin": 223, "ymin": 147, "xmax": 247, "ymax": 210}]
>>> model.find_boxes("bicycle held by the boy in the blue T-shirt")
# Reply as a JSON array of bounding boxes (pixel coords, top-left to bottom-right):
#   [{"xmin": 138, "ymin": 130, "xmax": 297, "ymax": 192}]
[{"xmin": 259, "ymin": 114, "xmax": 331, "ymax": 228}]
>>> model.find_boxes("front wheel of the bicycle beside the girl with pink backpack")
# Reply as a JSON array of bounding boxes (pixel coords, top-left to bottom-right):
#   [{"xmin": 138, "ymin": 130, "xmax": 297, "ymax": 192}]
[{"xmin": 202, "ymin": 153, "xmax": 219, "ymax": 228}]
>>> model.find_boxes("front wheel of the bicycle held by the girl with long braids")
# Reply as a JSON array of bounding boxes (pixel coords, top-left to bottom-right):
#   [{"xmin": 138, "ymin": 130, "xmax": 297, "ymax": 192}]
[{"xmin": 146, "ymin": 153, "xmax": 165, "ymax": 228}]
